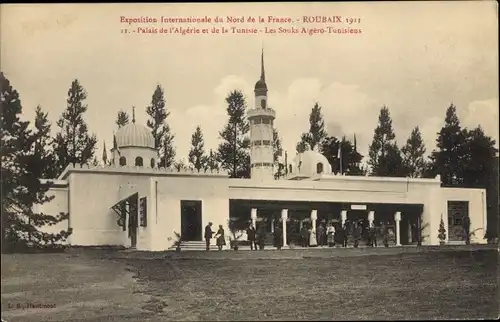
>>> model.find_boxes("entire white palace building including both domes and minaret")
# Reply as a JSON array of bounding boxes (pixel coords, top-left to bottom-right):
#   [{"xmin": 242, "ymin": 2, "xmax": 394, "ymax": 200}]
[{"xmin": 35, "ymin": 51, "xmax": 486, "ymax": 251}]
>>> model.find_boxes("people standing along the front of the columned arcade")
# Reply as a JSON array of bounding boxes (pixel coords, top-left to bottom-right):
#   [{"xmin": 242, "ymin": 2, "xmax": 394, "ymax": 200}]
[{"xmin": 204, "ymin": 220, "xmax": 398, "ymax": 250}]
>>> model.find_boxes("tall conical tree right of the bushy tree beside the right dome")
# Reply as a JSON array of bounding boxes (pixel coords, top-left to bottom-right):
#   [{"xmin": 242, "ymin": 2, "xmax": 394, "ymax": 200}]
[{"xmin": 368, "ymin": 106, "xmax": 404, "ymax": 177}]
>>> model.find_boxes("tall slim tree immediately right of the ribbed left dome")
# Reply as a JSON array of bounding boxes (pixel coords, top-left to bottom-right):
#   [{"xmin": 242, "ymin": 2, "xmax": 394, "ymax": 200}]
[{"xmin": 146, "ymin": 85, "xmax": 175, "ymax": 168}]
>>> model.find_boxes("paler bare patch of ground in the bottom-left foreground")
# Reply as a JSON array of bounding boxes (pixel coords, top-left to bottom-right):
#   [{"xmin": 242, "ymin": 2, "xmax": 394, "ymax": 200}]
[{"xmin": 1, "ymin": 253, "xmax": 151, "ymax": 322}]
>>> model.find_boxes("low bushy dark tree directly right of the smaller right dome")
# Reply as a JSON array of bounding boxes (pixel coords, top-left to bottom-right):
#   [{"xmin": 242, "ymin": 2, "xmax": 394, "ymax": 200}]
[{"xmin": 320, "ymin": 136, "xmax": 364, "ymax": 175}]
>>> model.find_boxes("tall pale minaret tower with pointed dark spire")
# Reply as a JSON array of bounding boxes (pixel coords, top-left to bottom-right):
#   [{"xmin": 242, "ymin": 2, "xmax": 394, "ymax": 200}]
[{"xmin": 248, "ymin": 49, "xmax": 276, "ymax": 180}]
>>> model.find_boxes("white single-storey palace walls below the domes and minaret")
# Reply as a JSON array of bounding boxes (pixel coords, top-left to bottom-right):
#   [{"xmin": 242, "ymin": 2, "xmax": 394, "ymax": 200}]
[{"xmin": 38, "ymin": 162, "xmax": 486, "ymax": 251}]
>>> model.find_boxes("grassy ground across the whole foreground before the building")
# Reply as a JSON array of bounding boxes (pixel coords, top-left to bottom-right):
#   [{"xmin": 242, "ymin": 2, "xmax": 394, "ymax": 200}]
[{"xmin": 2, "ymin": 249, "xmax": 498, "ymax": 321}]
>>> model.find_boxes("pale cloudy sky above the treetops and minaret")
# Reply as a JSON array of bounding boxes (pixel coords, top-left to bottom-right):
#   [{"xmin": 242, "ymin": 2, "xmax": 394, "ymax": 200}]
[{"xmin": 0, "ymin": 1, "xmax": 499, "ymax": 166}]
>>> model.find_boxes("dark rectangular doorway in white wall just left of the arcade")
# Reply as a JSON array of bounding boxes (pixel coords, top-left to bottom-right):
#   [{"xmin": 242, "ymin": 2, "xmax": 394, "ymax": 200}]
[{"xmin": 181, "ymin": 200, "xmax": 203, "ymax": 241}]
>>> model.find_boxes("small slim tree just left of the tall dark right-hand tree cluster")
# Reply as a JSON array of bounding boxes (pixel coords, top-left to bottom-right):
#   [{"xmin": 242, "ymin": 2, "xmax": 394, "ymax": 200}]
[{"xmin": 401, "ymin": 126, "xmax": 426, "ymax": 178}]
